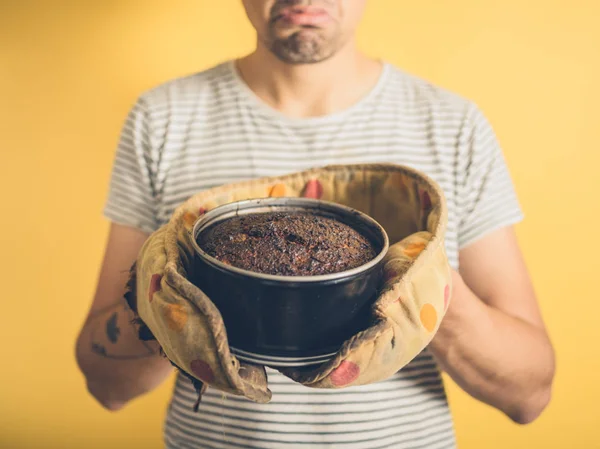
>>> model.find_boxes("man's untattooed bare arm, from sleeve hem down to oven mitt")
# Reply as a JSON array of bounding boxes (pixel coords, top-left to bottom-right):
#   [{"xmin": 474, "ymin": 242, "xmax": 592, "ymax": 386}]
[{"xmin": 429, "ymin": 227, "xmax": 555, "ymax": 424}]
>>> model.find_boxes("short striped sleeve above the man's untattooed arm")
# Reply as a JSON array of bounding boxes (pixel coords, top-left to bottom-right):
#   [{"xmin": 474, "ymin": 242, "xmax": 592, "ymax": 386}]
[{"xmin": 457, "ymin": 107, "xmax": 523, "ymax": 248}]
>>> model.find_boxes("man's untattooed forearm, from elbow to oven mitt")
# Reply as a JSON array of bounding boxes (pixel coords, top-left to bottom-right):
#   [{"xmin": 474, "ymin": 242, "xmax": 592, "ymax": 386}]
[{"xmin": 429, "ymin": 277, "xmax": 554, "ymax": 423}]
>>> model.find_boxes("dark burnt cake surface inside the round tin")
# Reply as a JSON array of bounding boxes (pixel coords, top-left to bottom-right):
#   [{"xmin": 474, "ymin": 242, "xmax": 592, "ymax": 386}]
[{"xmin": 198, "ymin": 212, "xmax": 377, "ymax": 276}]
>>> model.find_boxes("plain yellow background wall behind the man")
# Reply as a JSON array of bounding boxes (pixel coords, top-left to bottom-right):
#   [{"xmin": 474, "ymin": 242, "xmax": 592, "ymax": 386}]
[{"xmin": 0, "ymin": 0, "xmax": 600, "ymax": 449}]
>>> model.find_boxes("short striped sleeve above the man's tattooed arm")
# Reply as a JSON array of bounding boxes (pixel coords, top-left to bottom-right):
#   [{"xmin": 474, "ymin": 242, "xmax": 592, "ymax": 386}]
[{"xmin": 104, "ymin": 96, "xmax": 158, "ymax": 233}]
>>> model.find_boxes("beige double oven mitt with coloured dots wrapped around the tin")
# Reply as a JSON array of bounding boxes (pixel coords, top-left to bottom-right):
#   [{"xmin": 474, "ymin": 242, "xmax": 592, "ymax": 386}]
[{"xmin": 128, "ymin": 164, "xmax": 451, "ymax": 402}]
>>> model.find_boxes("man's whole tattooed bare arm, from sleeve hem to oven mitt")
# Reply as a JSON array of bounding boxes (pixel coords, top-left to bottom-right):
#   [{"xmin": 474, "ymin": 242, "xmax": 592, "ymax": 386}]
[{"xmin": 76, "ymin": 224, "xmax": 172, "ymax": 410}]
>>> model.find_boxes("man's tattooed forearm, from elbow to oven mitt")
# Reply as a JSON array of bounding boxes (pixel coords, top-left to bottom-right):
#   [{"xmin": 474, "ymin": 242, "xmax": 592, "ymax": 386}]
[{"xmin": 76, "ymin": 300, "xmax": 172, "ymax": 410}]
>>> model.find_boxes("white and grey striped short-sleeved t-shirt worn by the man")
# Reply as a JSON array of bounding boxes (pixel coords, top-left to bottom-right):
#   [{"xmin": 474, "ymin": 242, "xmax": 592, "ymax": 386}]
[{"xmin": 105, "ymin": 62, "xmax": 521, "ymax": 449}]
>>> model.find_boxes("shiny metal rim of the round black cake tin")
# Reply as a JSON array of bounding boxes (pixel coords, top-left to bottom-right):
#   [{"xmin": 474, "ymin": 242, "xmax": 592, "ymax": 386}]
[{"xmin": 191, "ymin": 197, "xmax": 389, "ymax": 283}]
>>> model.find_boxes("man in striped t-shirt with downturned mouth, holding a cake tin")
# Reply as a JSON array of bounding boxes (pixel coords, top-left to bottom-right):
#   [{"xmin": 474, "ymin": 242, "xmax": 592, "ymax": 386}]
[{"xmin": 77, "ymin": 0, "xmax": 554, "ymax": 449}]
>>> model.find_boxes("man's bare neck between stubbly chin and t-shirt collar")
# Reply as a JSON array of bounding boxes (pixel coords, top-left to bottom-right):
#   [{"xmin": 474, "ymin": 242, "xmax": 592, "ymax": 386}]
[{"xmin": 237, "ymin": 43, "xmax": 382, "ymax": 117}]
